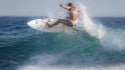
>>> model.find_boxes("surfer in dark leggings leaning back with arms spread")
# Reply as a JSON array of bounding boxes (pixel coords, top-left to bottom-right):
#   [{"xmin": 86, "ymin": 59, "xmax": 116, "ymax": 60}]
[{"xmin": 46, "ymin": 3, "xmax": 83, "ymax": 28}]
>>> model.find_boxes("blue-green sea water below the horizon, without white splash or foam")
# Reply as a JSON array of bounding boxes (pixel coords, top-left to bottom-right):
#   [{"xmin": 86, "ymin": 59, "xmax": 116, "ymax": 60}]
[{"xmin": 0, "ymin": 17, "xmax": 125, "ymax": 70}]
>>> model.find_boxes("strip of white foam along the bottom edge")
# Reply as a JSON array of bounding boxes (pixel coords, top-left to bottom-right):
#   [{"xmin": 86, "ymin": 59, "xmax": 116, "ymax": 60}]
[{"xmin": 17, "ymin": 65, "xmax": 125, "ymax": 70}]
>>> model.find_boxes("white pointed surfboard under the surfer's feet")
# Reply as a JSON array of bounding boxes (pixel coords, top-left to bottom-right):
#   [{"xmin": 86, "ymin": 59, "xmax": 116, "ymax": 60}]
[{"xmin": 27, "ymin": 18, "xmax": 68, "ymax": 32}]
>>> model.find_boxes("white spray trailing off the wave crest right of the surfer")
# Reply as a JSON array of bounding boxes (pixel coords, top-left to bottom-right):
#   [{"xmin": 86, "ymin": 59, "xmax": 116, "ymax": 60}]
[{"xmin": 81, "ymin": 13, "xmax": 125, "ymax": 50}]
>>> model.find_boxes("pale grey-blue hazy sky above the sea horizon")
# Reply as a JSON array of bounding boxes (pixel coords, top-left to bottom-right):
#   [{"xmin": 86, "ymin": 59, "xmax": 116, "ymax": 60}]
[{"xmin": 0, "ymin": 0, "xmax": 125, "ymax": 17}]
